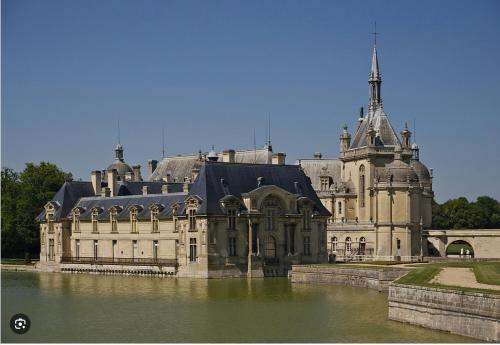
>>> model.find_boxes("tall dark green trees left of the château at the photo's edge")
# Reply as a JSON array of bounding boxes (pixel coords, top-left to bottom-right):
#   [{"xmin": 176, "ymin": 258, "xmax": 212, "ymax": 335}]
[{"xmin": 1, "ymin": 162, "xmax": 72, "ymax": 259}]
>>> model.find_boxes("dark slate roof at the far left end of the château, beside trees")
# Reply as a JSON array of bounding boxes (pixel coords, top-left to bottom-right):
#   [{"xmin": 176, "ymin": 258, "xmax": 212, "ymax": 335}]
[{"xmin": 36, "ymin": 181, "xmax": 94, "ymax": 221}]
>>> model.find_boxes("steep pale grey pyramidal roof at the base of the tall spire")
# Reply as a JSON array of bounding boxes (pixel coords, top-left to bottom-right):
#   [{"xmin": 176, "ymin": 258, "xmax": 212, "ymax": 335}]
[{"xmin": 351, "ymin": 107, "xmax": 401, "ymax": 149}]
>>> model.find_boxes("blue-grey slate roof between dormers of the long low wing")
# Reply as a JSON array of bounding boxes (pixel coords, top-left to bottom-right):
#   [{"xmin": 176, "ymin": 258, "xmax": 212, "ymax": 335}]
[{"xmin": 75, "ymin": 193, "xmax": 187, "ymax": 220}]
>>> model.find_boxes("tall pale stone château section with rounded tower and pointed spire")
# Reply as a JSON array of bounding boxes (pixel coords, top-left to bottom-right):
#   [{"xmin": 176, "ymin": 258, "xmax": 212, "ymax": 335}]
[{"xmin": 298, "ymin": 43, "xmax": 434, "ymax": 260}]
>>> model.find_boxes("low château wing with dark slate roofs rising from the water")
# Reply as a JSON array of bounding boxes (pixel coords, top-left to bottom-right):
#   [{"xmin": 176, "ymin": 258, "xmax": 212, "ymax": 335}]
[{"xmin": 39, "ymin": 161, "xmax": 330, "ymax": 278}]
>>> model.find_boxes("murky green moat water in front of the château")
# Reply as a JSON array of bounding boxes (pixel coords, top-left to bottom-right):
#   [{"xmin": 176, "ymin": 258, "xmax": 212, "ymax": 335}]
[{"xmin": 1, "ymin": 272, "xmax": 473, "ymax": 342}]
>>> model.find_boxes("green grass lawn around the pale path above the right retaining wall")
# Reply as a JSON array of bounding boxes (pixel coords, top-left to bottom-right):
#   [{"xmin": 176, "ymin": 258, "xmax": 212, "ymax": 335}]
[{"xmin": 396, "ymin": 262, "xmax": 500, "ymax": 294}]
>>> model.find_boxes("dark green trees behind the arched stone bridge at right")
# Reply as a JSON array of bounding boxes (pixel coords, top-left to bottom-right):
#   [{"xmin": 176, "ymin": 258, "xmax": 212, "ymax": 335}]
[{"xmin": 432, "ymin": 196, "xmax": 500, "ymax": 229}]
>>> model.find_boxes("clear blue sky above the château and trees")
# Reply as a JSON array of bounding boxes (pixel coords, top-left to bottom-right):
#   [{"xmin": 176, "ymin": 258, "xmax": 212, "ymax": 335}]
[{"xmin": 1, "ymin": 0, "xmax": 500, "ymax": 201}]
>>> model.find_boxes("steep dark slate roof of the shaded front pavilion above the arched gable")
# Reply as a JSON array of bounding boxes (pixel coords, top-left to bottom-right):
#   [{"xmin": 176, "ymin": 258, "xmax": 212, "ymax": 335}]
[{"xmin": 189, "ymin": 162, "xmax": 330, "ymax": 216}]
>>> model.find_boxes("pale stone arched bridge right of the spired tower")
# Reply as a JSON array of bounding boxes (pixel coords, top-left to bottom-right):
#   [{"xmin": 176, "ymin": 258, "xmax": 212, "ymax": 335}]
[{"xmin": 423, "ymin": 229, "xmax": 500, "ymax": 259}]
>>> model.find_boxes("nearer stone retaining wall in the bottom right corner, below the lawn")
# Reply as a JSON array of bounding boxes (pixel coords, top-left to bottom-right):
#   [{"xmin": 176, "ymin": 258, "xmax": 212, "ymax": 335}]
[{"xmin": 389, "ymin": 283, "xmax": 500, "ymax": 342}]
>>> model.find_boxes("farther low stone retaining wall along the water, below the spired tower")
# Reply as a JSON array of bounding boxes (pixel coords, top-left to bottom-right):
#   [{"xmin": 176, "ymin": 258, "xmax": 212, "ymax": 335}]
[{"xmin": 291, "ymin": 265, "xmax": 410, "ymax": 291}]
